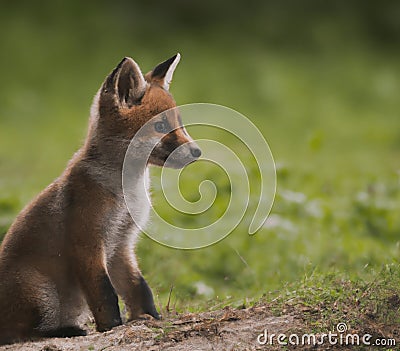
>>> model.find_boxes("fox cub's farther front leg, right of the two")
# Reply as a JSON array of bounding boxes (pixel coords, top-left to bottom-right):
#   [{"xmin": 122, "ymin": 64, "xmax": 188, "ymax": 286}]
[{"xmin": 108, "ymin": 250, "xmax": 160, "ymax": 320}]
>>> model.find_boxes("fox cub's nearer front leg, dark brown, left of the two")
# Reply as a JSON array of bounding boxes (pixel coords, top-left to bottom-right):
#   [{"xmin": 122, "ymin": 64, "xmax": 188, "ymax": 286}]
[{"xmin": 75, "ymin": 246, "xmax": 122, "ymax": 332}]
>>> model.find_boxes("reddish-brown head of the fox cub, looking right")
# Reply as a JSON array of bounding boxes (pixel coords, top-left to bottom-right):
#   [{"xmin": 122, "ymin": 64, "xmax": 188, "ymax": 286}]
[{"xmin": 90, "ymin": 54, "xmax": 201, "ymax": 168}]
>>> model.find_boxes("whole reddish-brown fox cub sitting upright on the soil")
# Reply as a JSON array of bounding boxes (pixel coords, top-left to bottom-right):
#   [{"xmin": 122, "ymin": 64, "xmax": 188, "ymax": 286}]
[{"xmin": 0, "ymin": 54, "xmax": 201, "ymax": 344}]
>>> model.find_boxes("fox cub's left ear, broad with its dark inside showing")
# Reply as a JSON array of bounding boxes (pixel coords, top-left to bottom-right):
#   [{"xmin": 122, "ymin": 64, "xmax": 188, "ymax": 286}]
[{"xmin": 102, "ymin": 57, "xmax": 147, "ymax": 108}]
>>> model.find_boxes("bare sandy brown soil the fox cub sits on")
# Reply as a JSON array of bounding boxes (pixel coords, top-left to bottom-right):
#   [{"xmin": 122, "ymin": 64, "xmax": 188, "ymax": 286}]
[{"xmin": 0, "ymin": 304, "xmax": 399, "ymax": 351}]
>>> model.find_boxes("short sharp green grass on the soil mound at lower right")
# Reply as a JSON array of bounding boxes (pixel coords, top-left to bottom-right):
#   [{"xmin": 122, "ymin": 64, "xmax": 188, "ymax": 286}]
[{"xmin": 262, "ymin": 264, "xmax": 400, "ymax": 350}]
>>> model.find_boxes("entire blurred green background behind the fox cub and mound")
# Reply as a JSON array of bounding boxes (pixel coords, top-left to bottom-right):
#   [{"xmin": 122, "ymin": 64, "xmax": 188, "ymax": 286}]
[{"xmin": 0, "ymin": 0, "xmax": 400, "ymax": 306}]
